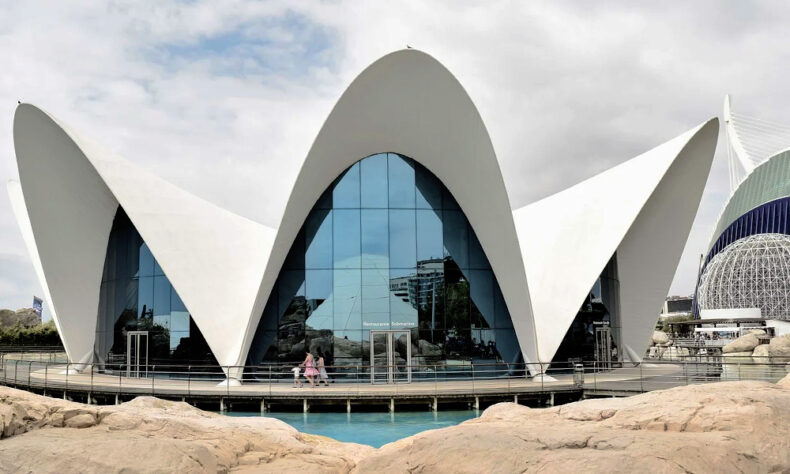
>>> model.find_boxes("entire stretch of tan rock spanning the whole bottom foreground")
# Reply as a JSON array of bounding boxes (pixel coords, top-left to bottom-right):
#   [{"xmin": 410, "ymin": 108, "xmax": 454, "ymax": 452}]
[{"xmin": 0, "ymin": 376, "xmax": 790, "ymax": 474}]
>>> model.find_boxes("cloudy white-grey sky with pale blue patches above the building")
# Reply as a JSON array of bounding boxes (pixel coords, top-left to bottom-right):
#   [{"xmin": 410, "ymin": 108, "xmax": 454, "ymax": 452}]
[{"xmin": 0, "ymin": 0, "xmax": 790, "ymax": 316}]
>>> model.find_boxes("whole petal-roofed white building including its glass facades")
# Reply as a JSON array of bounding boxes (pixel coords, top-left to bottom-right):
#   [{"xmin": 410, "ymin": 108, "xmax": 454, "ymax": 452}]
[{"xmin": 9, "ymin": 50, "xmax": 718, "ymax": 378}]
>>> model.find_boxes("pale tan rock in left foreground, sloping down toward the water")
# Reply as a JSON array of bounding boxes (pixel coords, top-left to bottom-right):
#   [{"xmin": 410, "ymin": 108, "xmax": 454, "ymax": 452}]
[{"xmin": 0, "ymin": 387, "xmax": 373, "ymax": 473}]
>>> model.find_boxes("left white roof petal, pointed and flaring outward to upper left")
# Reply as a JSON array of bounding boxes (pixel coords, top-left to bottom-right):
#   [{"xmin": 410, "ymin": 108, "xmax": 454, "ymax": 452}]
[{"xmin": 14, "ymin": 104, "xmax": 274, "ymax": 365}]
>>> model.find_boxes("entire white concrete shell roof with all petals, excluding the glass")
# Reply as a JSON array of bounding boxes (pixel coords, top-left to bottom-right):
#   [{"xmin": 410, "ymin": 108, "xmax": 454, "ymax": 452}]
[{"xmin": 9, "ymin": 50, "xmax": 718, "ymax": 377}]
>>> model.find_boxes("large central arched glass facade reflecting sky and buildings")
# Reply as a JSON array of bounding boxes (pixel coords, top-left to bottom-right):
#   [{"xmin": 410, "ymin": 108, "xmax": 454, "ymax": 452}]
[{"xmin": 248, "ymin": 153, "xmax": 521, "ymax": 366}]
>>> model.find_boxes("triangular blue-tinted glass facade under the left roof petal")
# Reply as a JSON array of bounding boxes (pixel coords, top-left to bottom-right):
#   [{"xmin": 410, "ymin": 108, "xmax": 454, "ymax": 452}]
[{"xmin": 95, "ymin": 207, "xmax": 216, "ymax": 363}]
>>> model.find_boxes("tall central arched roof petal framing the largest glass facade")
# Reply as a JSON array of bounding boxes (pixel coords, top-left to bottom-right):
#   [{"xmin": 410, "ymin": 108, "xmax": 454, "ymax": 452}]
[{"xmin": 240, "ymin": 49, "xmax": 537, "ymax": 361}]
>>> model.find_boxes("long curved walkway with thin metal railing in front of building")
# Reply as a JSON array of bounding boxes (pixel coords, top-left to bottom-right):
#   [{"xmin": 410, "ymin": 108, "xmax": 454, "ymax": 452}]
[{"xmin": 0, "ymin": 352, "xmax": 788, "ymax": 398}]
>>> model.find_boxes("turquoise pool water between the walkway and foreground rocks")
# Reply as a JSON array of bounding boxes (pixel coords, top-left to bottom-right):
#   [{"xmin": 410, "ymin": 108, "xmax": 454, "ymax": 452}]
[{"xmin": 226, "ymin": 410, "xmax": 478, "ymax": 448}]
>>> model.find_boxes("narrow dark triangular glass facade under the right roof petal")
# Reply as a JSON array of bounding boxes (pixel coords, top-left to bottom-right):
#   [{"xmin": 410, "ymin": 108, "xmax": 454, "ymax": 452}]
[{"xmin": 552, "ymin": 255, "xmax": 622, "ymax": 363}]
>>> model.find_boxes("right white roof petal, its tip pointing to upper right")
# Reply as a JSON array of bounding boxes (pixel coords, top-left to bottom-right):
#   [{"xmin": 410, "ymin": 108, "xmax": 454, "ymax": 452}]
[{"xmin": 513, "ymin": 119, "xmax": 718, "ymax": 361}]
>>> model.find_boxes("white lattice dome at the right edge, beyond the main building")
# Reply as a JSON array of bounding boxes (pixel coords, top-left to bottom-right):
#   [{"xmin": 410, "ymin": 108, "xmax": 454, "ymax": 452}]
[{"xmin": 697, "ymin": 234, "xmax": 790, "ymax": 319}]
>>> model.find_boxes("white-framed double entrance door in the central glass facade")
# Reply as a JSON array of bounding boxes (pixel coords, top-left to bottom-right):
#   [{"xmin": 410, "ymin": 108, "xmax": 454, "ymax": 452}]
[{"xmin": 370, "ymin": 330, "xmax": 411, "ymax": 383}]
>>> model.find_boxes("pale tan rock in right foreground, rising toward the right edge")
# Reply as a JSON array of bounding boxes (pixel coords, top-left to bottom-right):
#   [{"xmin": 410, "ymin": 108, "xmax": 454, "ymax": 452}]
[{"xmin": 355, "ymin": 381, "xmax": 790, "ymax": 473}]
